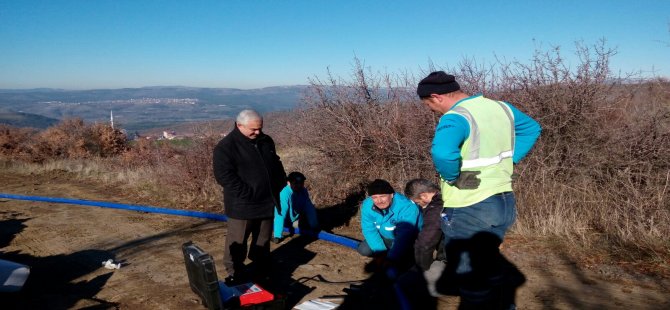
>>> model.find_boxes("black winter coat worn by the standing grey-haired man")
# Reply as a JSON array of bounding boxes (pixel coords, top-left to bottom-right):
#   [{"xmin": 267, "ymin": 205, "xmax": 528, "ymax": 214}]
[{"xmin": 213, "ymin": 126, "xmax": 286, "ymax": 220}]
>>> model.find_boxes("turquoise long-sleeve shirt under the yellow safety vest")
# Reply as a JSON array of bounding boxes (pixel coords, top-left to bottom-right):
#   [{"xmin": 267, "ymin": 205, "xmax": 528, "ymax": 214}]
[{"xmin": 431, "ymin": 95, "xmax": 542, "ymax": 181}]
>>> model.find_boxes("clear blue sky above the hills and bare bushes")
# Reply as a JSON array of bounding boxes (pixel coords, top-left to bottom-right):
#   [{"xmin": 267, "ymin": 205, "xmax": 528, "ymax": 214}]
[{"xmin": 0, "ymin": 0, "xmax": 670, "ymax": 89}]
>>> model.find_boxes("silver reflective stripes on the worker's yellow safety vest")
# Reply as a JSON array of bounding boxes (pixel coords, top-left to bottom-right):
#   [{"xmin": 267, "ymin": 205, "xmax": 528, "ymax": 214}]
[{"xmin": 452, "ymin": 101, "xmax": 514, "ymax": 169}]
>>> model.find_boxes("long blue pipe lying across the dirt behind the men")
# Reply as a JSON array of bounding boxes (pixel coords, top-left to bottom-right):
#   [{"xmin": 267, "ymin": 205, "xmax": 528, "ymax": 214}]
[{"xmin": 0, "ymin": 193, "xmax": 360, "ymax": 250}]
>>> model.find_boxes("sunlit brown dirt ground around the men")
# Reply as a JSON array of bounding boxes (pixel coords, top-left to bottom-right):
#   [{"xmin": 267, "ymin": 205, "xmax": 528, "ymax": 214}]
[{"xmin": 0, "ymin": 171, "xmax": 670, "ymax": 309}]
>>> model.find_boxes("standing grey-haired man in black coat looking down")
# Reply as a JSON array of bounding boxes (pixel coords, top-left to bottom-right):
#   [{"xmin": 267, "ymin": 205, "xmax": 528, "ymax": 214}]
[{"xmin": 213, "ymin": 110, "xmax": 286, "ymax": 284}]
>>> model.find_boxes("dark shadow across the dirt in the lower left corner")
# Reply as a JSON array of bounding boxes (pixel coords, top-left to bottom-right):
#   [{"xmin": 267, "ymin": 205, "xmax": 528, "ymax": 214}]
[{"xmin": 0, "ymin": 212, "xmax": 220, "ymax": 309}]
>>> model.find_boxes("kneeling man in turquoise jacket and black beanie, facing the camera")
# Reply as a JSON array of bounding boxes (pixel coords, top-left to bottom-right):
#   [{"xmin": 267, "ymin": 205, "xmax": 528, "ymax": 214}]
[{"xmin": 358, "ymin": 179, "xmax": 423, "ymax": 269}]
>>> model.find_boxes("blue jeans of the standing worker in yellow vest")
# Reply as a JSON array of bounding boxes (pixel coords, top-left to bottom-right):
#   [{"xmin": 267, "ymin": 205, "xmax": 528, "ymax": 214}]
[{"xmin": 441, "ymin": 192, "xmax": 516, "ymax": 245}]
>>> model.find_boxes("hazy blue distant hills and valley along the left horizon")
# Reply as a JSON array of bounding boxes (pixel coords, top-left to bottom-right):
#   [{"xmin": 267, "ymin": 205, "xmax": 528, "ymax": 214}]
[{"xmin": 0, "ymin": 85, "xmax": 307, "ymax": 130}]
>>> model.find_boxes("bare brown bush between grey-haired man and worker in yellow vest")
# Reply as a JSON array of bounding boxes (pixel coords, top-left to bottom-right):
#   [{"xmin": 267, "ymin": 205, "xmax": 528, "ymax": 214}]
[{"xmin": 287, "ymin": 60, "xmax": 435, "ymax": 200}]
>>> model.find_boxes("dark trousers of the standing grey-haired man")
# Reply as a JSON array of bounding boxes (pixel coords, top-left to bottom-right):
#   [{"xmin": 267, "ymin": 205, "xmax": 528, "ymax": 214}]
[{"xmin": 223, "ymin": 218, "xmax": 272, "ymax": 278}]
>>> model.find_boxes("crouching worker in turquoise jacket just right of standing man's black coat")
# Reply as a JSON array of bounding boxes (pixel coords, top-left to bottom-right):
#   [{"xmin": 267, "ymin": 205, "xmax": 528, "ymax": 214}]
[{"xmin": 272, "ymin": 172, "xmax": 319, "ymax": 243}]
